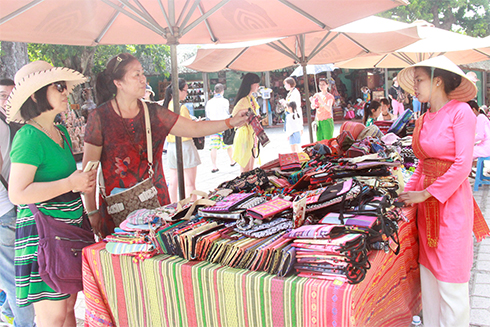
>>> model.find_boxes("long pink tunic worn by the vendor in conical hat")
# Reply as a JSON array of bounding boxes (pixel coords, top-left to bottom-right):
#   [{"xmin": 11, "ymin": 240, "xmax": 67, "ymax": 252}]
[{"xmin": 405, "ymin": 100, "xmax": 476, "ymax": 283}]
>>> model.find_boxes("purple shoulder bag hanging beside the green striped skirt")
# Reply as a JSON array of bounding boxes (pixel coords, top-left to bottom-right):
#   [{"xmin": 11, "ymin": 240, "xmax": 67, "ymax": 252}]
[{"xmin": 29, "ymin": 204, "xmax": 95, "ymax": 294}]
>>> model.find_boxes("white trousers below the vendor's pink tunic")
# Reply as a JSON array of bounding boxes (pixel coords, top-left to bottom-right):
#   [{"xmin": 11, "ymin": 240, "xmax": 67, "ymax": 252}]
[{"xmin": 419, "ymin": 265, "xmax": 470, "ymax": 327}]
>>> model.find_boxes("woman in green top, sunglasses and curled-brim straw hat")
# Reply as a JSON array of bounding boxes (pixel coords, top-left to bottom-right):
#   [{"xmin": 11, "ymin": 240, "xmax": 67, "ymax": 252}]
[{"xmin": 7, "ymin": 61, "xmax": 95, "ymax": 327}]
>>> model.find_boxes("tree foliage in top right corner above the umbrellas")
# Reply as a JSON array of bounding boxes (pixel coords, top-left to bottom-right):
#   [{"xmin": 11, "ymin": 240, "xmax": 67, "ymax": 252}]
[{"xmin": 380, "ymin": 0, "xmax": 490, "ymax": 37}]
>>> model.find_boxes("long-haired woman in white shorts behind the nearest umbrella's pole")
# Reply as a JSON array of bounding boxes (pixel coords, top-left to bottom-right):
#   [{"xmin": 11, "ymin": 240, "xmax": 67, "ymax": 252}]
[{"xmin": 163, "ymin": 78, "xmax": 201, "ymax": 203}]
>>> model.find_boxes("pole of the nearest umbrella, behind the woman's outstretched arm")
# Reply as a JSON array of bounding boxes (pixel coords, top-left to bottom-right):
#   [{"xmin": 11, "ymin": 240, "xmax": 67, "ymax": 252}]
[{"xmin": 168, "ymin": 42, "xmax": 185, "ymax": 200}]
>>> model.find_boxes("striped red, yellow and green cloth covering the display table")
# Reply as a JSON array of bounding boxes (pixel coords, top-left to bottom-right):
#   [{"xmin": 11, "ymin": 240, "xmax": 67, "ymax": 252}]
[{"xmin": 83, "ymin": 208, "xmax": 421, "ymax": 327}]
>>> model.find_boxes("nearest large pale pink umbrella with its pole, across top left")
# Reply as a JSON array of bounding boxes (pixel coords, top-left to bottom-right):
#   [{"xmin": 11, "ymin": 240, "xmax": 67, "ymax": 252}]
[{"xmin": 0, "ymin": 0, "xmax": 408, "ymax": 198}]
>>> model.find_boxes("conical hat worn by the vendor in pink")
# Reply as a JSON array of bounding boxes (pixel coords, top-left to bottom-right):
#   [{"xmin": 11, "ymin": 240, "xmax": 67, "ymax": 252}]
[{"xmin": 398, "ymin": 56, "xmax": 478, "ymax": 102}]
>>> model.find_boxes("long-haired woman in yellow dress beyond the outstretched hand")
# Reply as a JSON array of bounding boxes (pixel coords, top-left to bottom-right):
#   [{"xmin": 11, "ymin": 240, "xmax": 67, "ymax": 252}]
[{"xmin": 231, "ymin": 73, "xmax": 260, "ymax": 173}]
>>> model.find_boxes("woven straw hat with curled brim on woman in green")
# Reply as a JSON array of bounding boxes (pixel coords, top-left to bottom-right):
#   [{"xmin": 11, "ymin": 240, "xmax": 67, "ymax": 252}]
[{"xmin": 5, "ymin": 60, "xmax": 87, "ymax": 122}]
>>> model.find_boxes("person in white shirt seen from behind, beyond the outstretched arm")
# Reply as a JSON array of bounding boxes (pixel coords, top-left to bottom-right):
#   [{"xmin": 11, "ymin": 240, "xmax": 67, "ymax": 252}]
[{"xmin": 206, "ymin": 83, "xmax": 236, "ymax": 173}]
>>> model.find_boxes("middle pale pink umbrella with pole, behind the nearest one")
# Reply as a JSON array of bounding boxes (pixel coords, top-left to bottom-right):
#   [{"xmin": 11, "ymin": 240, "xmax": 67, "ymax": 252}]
[{"xmin": 186, "ymin": 16, "xmax": 420, "ymax": 142}]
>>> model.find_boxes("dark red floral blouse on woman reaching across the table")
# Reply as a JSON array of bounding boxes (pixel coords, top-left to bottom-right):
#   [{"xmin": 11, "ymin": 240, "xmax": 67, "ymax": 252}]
[{"xmin": 85, "ymin": 101, "xmax": 179, "ymax": 235}]
